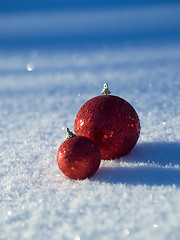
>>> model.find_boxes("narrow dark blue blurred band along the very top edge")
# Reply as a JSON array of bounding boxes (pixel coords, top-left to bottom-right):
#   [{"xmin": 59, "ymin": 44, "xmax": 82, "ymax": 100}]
[{"xmin": 0, "ymin": 0, "xmax": 180, "ymax": 13}]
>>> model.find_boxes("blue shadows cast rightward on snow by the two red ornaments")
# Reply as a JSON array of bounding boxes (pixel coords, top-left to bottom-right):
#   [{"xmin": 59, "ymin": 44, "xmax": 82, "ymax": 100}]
[{"xmin": 92, "ymin": 142, "xmax": 180, "ymax": 187}]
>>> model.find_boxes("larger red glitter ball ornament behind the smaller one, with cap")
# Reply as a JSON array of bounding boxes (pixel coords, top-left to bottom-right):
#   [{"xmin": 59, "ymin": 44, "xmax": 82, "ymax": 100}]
[{"xmin": 74, "ymin": 83, "xmax": 140, "ymax": 160}]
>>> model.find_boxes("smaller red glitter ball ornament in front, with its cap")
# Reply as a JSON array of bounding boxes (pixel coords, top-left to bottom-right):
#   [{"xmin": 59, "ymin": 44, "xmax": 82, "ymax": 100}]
[{"xmin": 57, "ymin": 128, "xmax": 101, "ymax": 180}]
